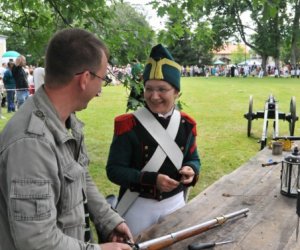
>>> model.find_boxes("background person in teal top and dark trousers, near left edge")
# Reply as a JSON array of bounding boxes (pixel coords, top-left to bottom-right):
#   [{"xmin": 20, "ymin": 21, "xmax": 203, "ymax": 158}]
[{"xmin": 3, "ymin": 62, "xmax": 16, "ymax": 113}]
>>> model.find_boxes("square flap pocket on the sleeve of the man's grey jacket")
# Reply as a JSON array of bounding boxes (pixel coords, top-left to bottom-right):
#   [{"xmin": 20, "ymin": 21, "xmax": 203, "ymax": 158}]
[{"xmin": 10, "ymin": 179, "xmax": 51, "ymax": 221}]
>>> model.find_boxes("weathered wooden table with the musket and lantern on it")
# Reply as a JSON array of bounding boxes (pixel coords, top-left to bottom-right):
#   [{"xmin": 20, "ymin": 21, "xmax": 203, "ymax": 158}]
[{"xmin": 139, "ymin": 148, "xmax": 300, "ymax": 250}]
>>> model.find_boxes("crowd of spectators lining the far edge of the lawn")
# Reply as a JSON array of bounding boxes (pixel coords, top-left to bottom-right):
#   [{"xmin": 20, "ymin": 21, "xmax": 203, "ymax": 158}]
[{"xmin": 0, "ymin": 55, "xmax": 300, "ymax": 119}]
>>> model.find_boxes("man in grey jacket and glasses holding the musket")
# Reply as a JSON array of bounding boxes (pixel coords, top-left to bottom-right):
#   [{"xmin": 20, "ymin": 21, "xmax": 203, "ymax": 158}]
[{"xmin": 0, "ymin": 29, "xmax": 132, "ymax": 250}]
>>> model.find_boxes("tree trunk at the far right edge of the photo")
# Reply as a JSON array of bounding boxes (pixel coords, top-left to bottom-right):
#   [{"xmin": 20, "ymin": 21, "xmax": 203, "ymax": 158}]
[{"xmin": 291, "ymin": 0, "xmax": 300, "ymax": 67}]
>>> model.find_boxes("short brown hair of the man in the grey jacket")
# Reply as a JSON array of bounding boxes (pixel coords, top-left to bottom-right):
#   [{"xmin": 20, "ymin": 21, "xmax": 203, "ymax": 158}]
[{"xmin": 45, "ymin": 28, "xmax": 109, "ymax": 86}]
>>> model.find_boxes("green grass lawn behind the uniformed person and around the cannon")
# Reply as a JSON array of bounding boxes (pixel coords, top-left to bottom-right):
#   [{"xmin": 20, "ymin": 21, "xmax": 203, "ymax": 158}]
[{"xmin": 0, "ymin": 77, "xmax": 300, "ymax": 198}]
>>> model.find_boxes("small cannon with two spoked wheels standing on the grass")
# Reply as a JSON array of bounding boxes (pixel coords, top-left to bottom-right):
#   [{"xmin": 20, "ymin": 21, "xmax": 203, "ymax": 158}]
[{"xmin": 244, "ymin": 94, "xmax": 298, "ymax": 149}]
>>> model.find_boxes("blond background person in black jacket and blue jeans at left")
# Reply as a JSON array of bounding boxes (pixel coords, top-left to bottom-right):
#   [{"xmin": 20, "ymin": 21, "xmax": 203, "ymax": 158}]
[{"xmin": 12, "ymin": 55, "xmax": 29, "ymax": 109}]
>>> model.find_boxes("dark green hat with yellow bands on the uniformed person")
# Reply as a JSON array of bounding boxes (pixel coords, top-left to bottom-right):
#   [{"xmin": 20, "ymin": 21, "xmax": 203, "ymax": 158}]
[{"xmin": 143, "ymin": 44, "xmax": 181, "ymax": 91}]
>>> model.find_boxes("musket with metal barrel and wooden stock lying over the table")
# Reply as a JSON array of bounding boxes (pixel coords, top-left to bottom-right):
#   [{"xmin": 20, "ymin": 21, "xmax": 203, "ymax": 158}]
[{"xmin": 132, "ymin": 208, "xmax": 249, "ymax": 250}]
